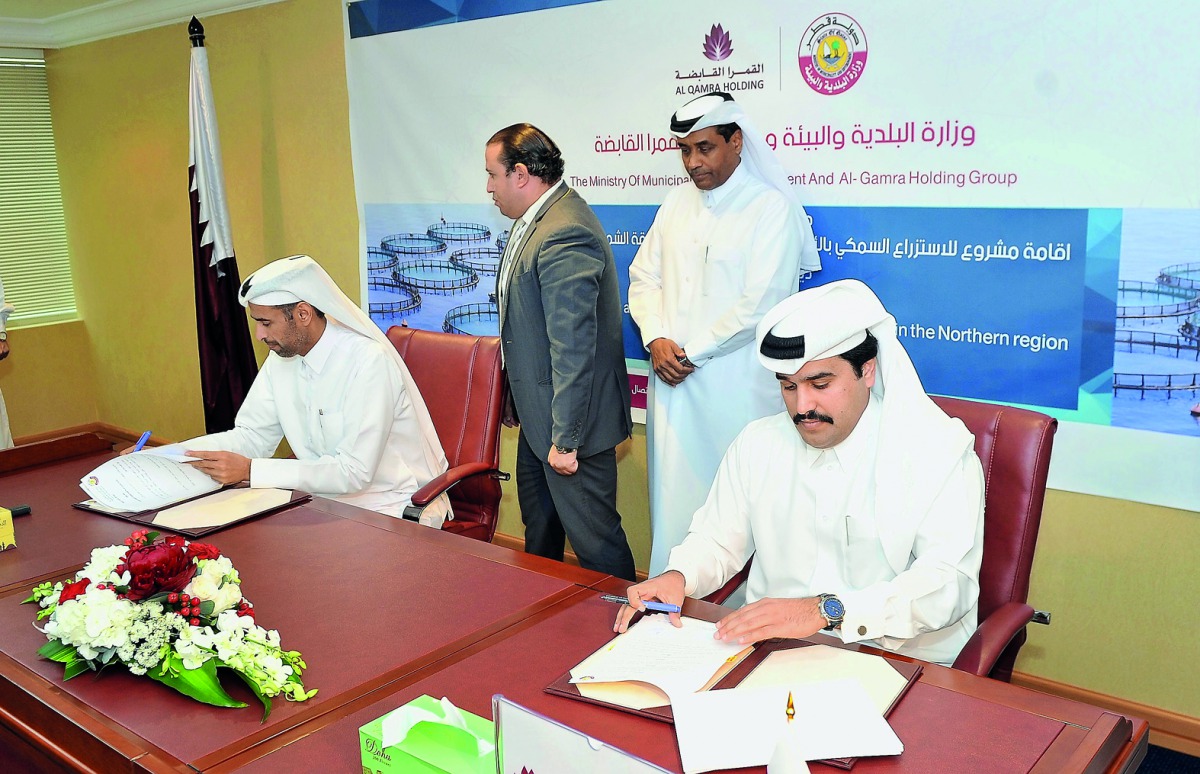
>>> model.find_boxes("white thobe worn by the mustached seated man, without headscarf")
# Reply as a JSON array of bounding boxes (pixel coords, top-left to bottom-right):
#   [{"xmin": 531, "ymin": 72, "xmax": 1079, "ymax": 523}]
[{"xmin": 667, "ymin": 396, "xmax": 984, "ymax": 664}]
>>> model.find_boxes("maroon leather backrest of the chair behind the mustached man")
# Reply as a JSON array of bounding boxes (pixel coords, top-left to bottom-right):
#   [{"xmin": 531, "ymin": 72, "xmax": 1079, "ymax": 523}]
[{"xmin": 934, "ymin": 396, "xmax": 1058, "ymax": 620}]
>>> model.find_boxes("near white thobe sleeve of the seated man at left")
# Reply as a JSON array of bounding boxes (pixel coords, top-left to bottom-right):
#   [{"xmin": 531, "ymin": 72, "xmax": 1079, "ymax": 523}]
[{"xmin": 250, "ymin": 356, "xmax": 400, "ymax": 494}]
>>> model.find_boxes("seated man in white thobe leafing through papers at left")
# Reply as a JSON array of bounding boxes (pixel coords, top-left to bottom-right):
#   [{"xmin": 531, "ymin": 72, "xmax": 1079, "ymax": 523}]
[{"xmin": 180, "ymin": 256, "xmax": 450, "ymax": 527}]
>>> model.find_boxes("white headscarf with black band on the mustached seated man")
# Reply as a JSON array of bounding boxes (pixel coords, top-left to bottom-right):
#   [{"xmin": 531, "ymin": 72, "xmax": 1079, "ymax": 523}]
[{"xmin": 755, "ymin": 280, "xmax": 974, "ymax": 572}]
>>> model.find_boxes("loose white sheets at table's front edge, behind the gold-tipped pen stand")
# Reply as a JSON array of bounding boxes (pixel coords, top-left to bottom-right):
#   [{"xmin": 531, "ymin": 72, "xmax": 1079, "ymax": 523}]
[{"xmin": 671, "ymin": 680, "xmax": 904, "ymax": 774}]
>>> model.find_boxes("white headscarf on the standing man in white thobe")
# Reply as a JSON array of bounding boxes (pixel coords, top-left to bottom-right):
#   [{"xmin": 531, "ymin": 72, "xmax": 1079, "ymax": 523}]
[{"xmin": 671, "ymin": 91, "xmax": 821, "ymax": 271}]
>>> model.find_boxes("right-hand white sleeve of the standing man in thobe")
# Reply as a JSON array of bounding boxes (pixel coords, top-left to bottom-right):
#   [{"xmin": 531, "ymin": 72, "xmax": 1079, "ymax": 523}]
[{"xmin": 678, "ymin": 196, "xmax": 803, "ymax": 366}]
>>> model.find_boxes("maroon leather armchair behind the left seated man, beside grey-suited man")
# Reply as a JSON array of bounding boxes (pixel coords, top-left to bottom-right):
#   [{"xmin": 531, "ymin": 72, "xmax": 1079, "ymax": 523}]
[{"xmin": 388, "ymin": 325, "xmax": 509, "ymax": 542}]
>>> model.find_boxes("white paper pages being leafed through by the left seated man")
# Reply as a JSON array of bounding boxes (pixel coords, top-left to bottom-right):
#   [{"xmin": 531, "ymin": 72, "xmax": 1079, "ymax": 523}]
[{"xmin": 79, "ymin": 452, "xmax": 221, "ymax": 512}]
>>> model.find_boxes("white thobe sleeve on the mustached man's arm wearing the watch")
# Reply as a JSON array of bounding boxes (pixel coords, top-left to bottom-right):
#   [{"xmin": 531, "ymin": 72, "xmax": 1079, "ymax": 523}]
[{"xmin": 838, "ymin": 452, "xmax": 984, "ymax": 648}]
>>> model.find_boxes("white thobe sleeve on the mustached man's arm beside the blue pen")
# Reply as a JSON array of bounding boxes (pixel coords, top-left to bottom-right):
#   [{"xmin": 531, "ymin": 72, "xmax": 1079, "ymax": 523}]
[{"xmin": 666, "ymin": 437, "xmax": 754, "ymax": 596}]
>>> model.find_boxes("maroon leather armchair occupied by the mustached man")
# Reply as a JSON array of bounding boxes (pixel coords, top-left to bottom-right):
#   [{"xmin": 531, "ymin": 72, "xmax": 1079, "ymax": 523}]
[{"xmin": 704, "ymin": 396, "xmax": 1058, "ymax": 683}]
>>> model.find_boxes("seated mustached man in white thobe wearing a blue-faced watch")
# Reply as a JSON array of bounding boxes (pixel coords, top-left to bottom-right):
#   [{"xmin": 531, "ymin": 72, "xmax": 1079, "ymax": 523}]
[{"xmin": 614, "ymin": 280, "xmax": 984, "ymax": 665}]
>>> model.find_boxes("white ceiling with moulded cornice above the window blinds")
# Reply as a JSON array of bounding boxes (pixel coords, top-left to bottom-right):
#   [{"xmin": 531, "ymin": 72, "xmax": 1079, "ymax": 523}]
[{"xmin": 0, "ymin": 0, "xmax": 282, "ymax": 49}]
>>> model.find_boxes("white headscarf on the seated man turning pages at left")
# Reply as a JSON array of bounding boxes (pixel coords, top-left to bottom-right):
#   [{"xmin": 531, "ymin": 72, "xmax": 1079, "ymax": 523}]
[{"xmin": 238, "ymin": 256, "xmax": 450, "ymax": 480}]
